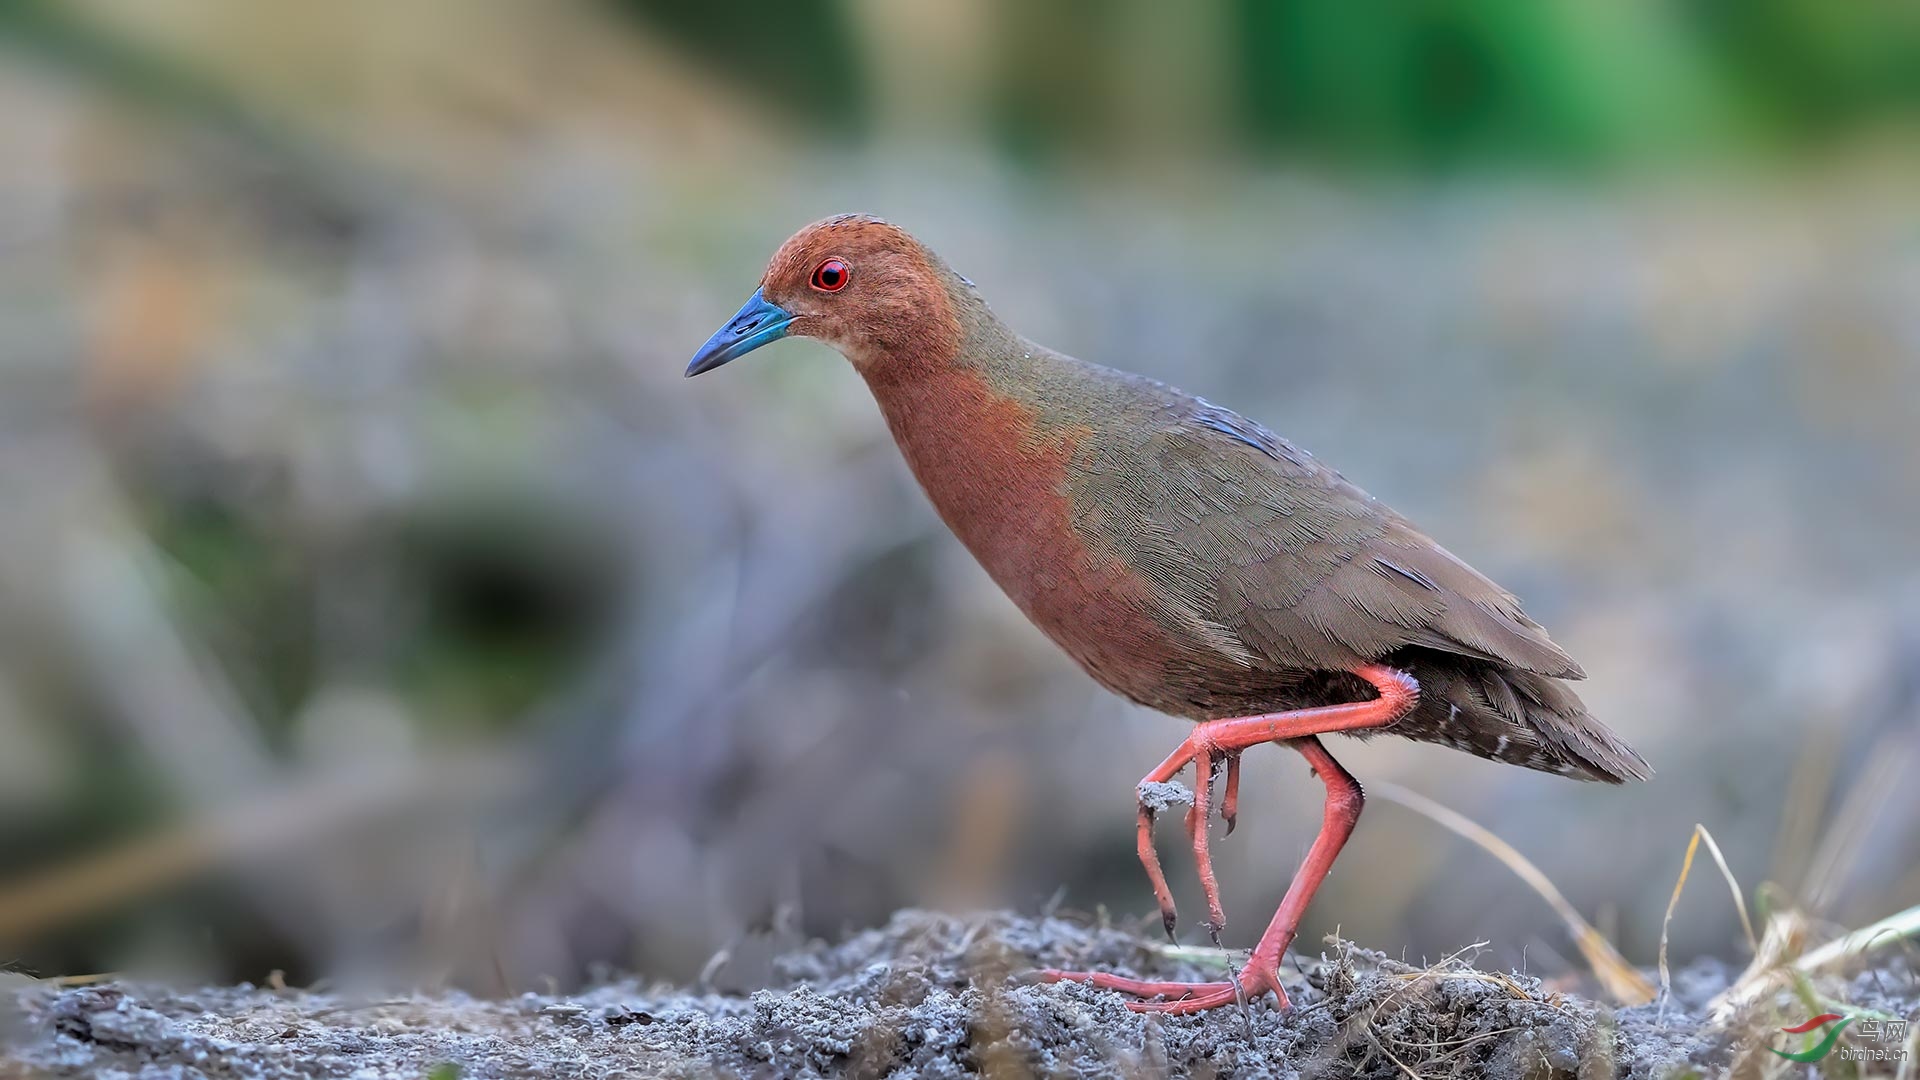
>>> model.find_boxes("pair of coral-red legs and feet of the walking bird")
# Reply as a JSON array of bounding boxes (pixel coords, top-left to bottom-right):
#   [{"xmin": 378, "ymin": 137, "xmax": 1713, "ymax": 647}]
[{"xmin": 1041, "ymin": 665, "xmax": 1419, "ymax": 1013}]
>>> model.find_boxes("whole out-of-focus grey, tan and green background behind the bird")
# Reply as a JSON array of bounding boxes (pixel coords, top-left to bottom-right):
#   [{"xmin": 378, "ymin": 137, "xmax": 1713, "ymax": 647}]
[{"xmin": 0, "ymin": 0, "xmax": 1920, "ymax": 992}]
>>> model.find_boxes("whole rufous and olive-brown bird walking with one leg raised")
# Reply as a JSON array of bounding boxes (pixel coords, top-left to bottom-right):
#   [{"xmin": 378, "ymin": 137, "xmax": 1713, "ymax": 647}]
[{"xmin": 685, "ymin": 213, "xmax": 1651, "ymax": 1015}]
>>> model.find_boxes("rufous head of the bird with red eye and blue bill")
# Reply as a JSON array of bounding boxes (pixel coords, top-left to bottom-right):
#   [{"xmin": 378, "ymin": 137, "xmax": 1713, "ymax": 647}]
[{"xmin": 687, "ymin": 213, "xmax": 960, "ymax": 377}]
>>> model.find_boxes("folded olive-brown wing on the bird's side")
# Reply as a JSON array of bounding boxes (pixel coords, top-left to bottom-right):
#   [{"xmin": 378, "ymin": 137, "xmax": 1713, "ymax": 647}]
[{"xmin": 1110, "ymin": 400, "xmax": 1584, "ymax": 678}]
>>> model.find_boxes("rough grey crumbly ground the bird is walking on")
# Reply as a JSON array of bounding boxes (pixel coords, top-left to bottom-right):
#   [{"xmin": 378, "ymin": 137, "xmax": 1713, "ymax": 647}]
[{"xmin": 0, "ymin": 911, "xmax": 1920, "ymax": 1078}]
